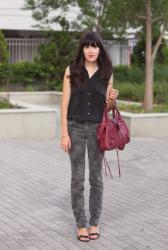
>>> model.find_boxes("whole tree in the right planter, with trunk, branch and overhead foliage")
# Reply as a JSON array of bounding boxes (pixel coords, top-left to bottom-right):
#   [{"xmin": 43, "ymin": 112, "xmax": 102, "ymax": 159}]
[{"xmin": 77, "ymin": 0, "xmax": 168, "ymax": 111}]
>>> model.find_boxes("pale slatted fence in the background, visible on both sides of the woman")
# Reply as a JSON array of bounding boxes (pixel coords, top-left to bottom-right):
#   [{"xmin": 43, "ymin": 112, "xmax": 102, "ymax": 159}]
[{"xmin": 7, "ymin": 38, "xmax": 135, "ymax": 65}]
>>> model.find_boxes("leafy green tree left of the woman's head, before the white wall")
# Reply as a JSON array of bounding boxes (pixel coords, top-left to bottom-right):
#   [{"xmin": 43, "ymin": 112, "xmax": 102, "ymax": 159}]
[{"xmin": 24, "ymin": 0, "xmax": 79, "ymax": 89}]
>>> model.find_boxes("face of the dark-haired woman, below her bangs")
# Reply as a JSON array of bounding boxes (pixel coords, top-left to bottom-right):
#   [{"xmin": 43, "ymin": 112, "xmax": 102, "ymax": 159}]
[{"xmin": 83, "ymin": 44, "xmax": 100, "ymax": 62}]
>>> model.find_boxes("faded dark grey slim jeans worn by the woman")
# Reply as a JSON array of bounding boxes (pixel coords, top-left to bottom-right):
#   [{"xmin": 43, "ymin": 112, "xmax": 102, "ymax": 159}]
[{"xmin": 68, "ymin": 120, "xmax": 104, "ymax": 228}]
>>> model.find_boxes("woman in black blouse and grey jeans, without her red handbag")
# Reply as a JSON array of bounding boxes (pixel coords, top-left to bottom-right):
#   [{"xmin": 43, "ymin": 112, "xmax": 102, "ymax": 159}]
[{"xmin": 61, "ymin": 31, "xmax": 118, "ymax": 242}]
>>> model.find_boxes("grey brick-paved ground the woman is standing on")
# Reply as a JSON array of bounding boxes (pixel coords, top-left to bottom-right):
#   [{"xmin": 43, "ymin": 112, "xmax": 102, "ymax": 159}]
[{"xmin": 0, "ymin": 139, "xmax": 168, "ymax": 250}]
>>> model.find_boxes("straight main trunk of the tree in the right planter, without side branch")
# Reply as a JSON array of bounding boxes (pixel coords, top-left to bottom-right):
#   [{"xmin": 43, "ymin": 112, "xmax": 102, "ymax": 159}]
[{"xmin": 144, "ymin": 0, "xmax": 154, "ymax": 112}]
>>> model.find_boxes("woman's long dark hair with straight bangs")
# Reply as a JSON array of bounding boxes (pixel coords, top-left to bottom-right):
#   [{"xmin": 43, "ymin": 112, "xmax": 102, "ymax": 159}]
[{"xmin": 70, "ymin": 31, "xmax": 113, "ymax": 86}]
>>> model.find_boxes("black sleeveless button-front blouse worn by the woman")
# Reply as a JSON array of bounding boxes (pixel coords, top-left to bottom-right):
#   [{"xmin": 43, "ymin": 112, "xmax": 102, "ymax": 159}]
[{"xmin": 67, "ymin": 65, "xmax": 107, "ymax": 122}]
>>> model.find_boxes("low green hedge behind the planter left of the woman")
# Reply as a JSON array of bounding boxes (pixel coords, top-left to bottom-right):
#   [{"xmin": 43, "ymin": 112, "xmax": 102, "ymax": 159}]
[{"xmin": 0, "ymin": 62, "xmax": 65, "ymax": 91}]
